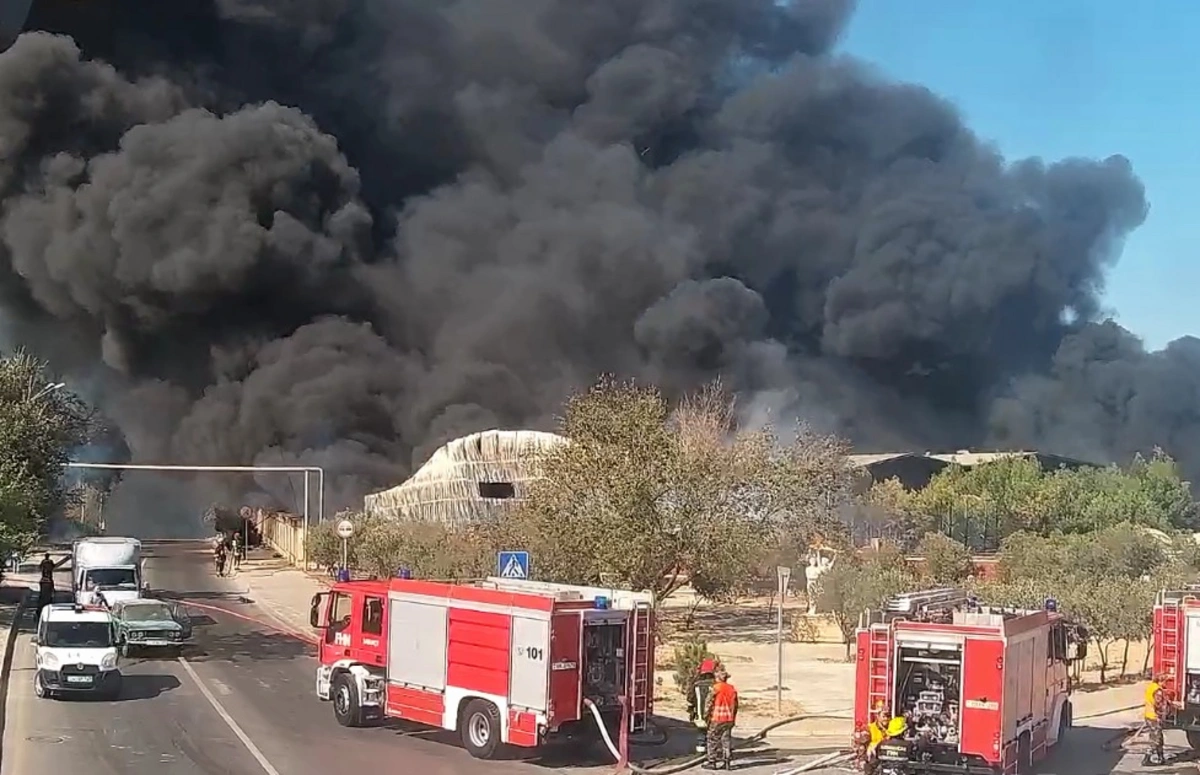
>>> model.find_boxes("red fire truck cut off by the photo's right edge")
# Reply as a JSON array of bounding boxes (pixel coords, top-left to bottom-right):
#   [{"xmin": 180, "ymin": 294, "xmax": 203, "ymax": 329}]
[{"xmin": 1151, "ymin": 585, "xmax": 1200, "ymax": 750}]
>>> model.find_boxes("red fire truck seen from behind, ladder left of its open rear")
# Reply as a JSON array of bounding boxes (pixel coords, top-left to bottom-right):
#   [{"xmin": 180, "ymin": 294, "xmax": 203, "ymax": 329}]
[{"xmin": 854, "ymin": 588, "xmax": 1086, "ymax": 774}]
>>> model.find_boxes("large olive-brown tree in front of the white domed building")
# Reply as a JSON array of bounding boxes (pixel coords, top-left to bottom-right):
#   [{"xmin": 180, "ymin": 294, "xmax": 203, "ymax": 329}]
[{"xmin": 506, "ymin": 379, "xmax": 853, "ymax": 601}]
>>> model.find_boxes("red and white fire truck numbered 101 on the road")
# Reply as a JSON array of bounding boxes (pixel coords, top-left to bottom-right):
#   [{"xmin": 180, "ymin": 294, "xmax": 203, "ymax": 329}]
[{"xmin": 310, "ymin": 578, "xmax": 654, "ymax": 758}]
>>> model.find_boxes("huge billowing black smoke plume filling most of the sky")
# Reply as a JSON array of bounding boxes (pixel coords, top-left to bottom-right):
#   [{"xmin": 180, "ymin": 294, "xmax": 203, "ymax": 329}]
[{"xmin": 0, "ymin": 0, "xmax": 1185, "ymax": 525}]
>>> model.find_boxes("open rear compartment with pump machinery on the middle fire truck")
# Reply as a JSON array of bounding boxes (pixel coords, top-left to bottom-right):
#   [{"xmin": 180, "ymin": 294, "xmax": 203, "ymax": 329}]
[{"xmin": 893, "ymin": 641, "xmax": 962, "ymax": 763}]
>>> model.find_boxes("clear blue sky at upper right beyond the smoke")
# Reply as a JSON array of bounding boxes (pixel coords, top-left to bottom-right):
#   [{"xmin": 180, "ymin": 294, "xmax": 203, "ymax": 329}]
[{"xmin": 842, "ymin": 0, "xmax": 1200, "ymax": 349}]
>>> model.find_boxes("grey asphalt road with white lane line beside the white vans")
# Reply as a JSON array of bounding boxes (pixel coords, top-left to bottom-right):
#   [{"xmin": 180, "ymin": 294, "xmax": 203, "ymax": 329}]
[{"xmin": 0, "ymin": 542, "xmax": 1180, "ymax": 775}]
